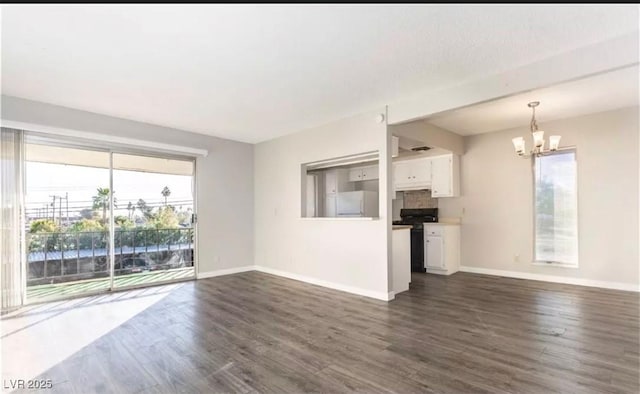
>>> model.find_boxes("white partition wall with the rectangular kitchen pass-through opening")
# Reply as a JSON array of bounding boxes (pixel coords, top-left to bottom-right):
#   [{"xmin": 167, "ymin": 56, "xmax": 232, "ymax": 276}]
[{"xmin": 254, "ymin": 109, "xmax": 391, "ymax": 299}]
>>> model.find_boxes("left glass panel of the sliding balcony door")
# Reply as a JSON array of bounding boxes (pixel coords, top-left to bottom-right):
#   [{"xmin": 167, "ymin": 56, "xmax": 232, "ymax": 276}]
[{"xmin": 25, "ymin": 142, "xmax": 110, "ymax": 302}]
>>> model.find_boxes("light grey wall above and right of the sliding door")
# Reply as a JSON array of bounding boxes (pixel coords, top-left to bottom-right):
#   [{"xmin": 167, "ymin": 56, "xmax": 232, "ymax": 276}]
[{"xmin": 2, "ymin": 96, "xmax": 253, "ymax": 274}]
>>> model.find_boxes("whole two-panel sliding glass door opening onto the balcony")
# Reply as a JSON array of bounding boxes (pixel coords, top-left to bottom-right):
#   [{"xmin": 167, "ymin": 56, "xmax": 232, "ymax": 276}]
[{"xmin": 24, "ymin": 136, "xmax": 195, "ymax": 302}]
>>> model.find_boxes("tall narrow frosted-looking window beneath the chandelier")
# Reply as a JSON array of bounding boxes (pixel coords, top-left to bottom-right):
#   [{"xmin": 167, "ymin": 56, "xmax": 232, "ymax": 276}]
[{"xmin": 534, "ymin": 149, "xmax": 578, "ymax": 267}]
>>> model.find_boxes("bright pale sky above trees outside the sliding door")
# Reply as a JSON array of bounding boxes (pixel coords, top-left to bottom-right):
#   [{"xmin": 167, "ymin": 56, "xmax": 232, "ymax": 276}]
[{"xmin": 25, "ymin": 162, "xmax": 193, "ymax": 217}]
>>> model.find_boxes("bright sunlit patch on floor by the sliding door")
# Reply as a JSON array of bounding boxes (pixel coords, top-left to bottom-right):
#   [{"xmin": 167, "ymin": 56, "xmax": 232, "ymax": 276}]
[{"xmin": 0, "ymin": 283, "xmax": 184, "ymax": 381}]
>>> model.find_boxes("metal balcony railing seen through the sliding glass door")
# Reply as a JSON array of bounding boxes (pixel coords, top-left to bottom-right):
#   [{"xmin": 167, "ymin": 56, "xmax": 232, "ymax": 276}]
[{"xmin": 27, "ymin": 228, "xmax": 193, "ymax": 285}]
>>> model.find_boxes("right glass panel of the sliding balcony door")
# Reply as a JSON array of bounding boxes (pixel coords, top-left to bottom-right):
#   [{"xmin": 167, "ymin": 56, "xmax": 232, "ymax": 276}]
[{"xmin": 113, "ymin": 153, "xmax": 195, "ymax": 288}]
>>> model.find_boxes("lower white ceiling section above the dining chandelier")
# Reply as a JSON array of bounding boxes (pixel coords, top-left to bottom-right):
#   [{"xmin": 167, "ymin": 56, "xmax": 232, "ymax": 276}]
[{"xmin": 426, "ymin": 65, "xmax": 640, "ymax": 136}]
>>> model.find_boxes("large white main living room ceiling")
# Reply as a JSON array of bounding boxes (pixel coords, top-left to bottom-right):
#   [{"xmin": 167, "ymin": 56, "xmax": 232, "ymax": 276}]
[{"xmin": 2, "ymin": 4, "xmax": 638, "ymax": 142}]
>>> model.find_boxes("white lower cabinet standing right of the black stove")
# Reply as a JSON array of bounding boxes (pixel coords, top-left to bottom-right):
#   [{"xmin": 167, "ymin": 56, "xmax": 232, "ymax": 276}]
[{"xmin": 424, "ymin": 223, "xmax": 460, "ymax": 275}]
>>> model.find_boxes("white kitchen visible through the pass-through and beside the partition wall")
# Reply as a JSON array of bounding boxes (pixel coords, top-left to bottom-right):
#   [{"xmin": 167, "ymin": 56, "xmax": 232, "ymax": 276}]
[{"xmin": 301, "ymin": 127, "xmax": 460, "ymax": 294}]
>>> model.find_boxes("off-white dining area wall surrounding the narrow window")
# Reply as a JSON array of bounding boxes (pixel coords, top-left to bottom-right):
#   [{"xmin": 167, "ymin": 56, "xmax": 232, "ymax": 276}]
[{"xmin": 439, "ymin": 107, "xmax": 640, "ymax": 288}]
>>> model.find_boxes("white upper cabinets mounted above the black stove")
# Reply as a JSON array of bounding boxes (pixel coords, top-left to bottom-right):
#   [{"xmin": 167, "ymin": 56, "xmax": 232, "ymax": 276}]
[{"xmin": 393, "ymin": 154, "xmax": 460, "ymax": 197}]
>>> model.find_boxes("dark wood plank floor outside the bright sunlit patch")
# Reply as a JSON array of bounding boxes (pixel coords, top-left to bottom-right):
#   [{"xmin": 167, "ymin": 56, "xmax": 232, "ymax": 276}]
[{"xmin": 11, "ymin": 272, "xmax": 640, "ymax": 393}]
